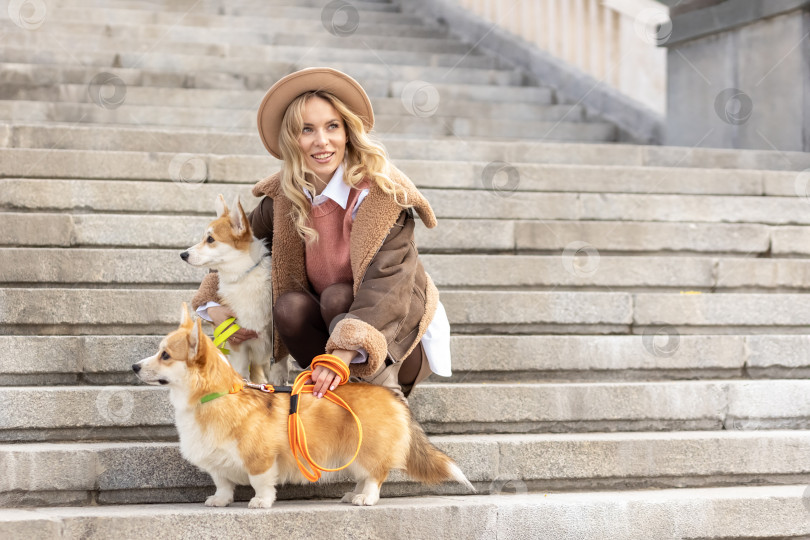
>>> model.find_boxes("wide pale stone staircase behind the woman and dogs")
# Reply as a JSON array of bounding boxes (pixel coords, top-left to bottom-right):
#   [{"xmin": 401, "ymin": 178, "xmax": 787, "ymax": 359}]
[{"xmin": 0, "ymin": 0, "xmax": 810, "ymax": 539}]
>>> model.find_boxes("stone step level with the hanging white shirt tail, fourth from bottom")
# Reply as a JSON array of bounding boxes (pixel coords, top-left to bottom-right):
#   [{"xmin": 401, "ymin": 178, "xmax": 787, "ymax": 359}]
[{"xmin": 0, "ymin": 334, "xmax": 810, "ymax": 386}]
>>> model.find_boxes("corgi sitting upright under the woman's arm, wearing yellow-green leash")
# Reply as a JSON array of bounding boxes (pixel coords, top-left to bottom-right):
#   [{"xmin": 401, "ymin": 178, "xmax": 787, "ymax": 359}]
[{"xmin": 180, "ymin": 195, "xmax": 289, "ymax": 385}]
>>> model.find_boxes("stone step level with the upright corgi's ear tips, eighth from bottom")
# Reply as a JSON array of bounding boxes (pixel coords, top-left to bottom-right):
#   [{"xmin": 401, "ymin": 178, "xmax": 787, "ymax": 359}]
[{"xmin": 6, "ymin": 178, "xmax": 810, "ymax": 225}]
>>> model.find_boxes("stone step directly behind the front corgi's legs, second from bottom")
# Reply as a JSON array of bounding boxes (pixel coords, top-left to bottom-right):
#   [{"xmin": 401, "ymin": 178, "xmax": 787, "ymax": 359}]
[{"xmin": 0, "ymin": 431, "xmax": 810, "ymax": 507}]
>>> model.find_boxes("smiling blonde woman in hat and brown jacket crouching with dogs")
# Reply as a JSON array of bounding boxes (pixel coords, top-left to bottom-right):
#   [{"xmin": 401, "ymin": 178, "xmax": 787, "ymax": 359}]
[{"xmin": 192, "ymin": 68, "xmax": 450, "ymax": 397}]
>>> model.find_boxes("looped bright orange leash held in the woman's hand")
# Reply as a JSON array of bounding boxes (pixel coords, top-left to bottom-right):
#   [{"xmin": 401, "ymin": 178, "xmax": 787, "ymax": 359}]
[{"xmin": 287, "ymin": 354, "xmax": 363, "ymax": 482}]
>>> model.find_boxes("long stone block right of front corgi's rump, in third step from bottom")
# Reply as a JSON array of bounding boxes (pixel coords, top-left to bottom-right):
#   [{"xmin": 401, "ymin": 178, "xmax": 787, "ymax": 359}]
[{"xmin": 410, "ymin": 382, "xmax": 724, "ymax": 432}]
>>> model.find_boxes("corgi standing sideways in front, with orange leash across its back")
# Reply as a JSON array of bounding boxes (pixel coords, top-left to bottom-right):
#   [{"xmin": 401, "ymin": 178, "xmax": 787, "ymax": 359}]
[{"xmin": 132, "ymin": 304, "xmax": 475, "ymax": 508}]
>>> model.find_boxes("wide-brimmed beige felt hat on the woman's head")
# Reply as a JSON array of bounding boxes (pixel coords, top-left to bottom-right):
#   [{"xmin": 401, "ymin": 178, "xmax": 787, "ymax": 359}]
[{"xmin": 257, "ymin": 67, "xmax": 374, "ymax": 159}]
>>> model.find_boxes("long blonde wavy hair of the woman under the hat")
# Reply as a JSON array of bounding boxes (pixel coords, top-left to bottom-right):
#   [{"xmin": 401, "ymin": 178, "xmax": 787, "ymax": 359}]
[{"xmin": 279, "ymin": 90, "xmax": 411, "ymax": 242}]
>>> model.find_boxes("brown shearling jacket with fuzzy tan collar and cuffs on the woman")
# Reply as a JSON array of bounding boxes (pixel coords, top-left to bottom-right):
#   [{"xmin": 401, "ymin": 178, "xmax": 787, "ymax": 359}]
[{"xmin": 192, "ymin": 167, "xmax": 439, "ymax": 379}]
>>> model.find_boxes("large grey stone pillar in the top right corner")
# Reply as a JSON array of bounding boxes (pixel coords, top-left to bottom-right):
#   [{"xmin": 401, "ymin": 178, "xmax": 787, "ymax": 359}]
[{"xmin": 663, "ymin": 0, "xmax": 810, "ymax": 151}]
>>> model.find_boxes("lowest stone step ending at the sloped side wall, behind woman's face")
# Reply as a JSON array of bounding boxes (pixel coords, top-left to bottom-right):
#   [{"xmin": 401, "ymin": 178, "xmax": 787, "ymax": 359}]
[{"xmin": 0, "ymin": 100, "xmax": 616, "ymax": 142}]
